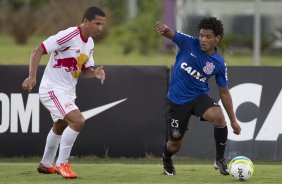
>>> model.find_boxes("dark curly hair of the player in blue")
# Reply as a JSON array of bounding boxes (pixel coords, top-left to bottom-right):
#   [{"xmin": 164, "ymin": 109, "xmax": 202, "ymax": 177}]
[{"xmin": 198, "ymin": 17, "xmax": 223, "ymax": 38}]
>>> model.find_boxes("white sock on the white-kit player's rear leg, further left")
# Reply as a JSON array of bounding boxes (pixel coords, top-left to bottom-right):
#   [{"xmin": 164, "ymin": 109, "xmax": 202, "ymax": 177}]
[{"xmin": 41, "ymin": 128, "xmax": 62, "ymax": 167}]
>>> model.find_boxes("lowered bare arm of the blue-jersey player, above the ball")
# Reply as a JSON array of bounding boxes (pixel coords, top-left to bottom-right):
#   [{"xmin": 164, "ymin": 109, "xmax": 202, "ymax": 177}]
[{"xmin": 218, "ymin": 87, "xmax": 241, "ymax": 135}]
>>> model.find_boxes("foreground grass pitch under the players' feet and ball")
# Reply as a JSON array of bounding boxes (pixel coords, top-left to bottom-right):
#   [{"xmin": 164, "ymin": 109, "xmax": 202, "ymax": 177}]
[{"xmin": 0, "ymin": 158, "xmax": 282, "ymax": 184}]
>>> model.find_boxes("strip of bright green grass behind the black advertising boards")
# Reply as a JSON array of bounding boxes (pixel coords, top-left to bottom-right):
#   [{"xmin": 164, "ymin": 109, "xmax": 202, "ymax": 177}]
[{"xmin": 0, "ymin": 34, "xmax": 282, "ymax": 66}]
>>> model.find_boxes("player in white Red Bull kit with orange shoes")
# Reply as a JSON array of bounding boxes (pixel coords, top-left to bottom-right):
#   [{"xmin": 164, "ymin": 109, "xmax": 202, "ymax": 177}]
[{"xmin": 22, "ymin": 6, "xmax": 106, "ymax": 178}]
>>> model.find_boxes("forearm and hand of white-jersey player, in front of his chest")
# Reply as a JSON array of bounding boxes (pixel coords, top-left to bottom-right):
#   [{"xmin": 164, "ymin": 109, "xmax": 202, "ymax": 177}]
[{"xmin": 81, "ymin": 66, "xmax": 106, "ymax": 84}]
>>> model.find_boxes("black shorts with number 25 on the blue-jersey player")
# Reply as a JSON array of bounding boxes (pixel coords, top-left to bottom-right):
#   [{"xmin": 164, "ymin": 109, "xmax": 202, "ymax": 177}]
[{"xmin": 167, "ymin": 95, "xmax": 219, "ymax": 141}]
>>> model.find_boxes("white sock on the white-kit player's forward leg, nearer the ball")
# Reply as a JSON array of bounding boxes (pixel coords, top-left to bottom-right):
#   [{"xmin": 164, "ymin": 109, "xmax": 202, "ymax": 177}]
[{"xmin": 56, "ymin": 126, "xmax": 79, "ymax": 165}]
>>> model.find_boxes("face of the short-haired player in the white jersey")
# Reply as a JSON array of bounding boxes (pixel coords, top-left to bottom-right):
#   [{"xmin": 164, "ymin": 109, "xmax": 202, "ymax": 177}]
[{"xmin": 87, "ymin": 16, "xmax": 106, "ymax": 38}]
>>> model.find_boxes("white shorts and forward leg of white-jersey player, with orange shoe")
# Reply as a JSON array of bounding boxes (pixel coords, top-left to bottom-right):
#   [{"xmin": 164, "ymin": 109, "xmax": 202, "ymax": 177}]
[{"xmin": 40, "ymin": 89, "xmax": 80, "ymax": 178}]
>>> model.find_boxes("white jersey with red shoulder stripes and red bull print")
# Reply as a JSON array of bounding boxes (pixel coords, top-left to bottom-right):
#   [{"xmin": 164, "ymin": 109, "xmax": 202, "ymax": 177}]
[{"xmin": 39, "ymin": 27, "xmax": 94, "ymax": 92}]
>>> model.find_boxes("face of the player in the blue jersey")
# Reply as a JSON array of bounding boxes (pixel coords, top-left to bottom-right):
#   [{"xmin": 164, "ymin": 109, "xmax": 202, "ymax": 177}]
[{"xmin": 199, "ymin": 29, "xmax": 220, "ymax": 54}]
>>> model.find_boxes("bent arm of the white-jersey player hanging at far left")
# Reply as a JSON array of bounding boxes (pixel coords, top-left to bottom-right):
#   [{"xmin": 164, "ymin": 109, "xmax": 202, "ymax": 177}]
[{"xmin": 22, "ymin": 45, "xmax": 44, "ymax": 92}]
